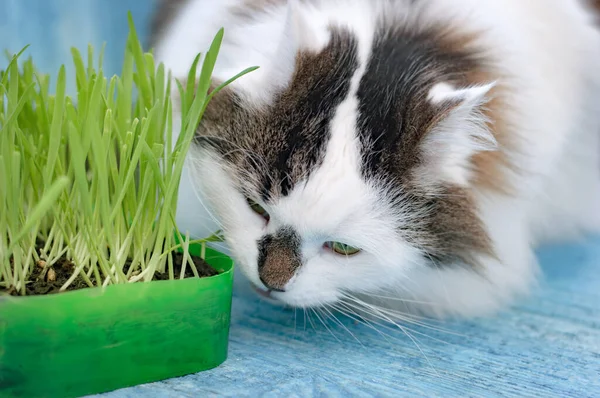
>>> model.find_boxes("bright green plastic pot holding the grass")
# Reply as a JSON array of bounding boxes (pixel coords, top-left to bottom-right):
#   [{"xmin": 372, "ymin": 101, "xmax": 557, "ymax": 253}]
[{"xmin": 0, "ymin": 241, "xmax": 233, "ymax": 398}]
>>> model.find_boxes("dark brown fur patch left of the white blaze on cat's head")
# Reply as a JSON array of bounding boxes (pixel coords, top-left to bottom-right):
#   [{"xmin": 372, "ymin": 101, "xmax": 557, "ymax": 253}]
[{"xmin": 198, "ymin": 25, "xmax": 359, "ymax": 202}]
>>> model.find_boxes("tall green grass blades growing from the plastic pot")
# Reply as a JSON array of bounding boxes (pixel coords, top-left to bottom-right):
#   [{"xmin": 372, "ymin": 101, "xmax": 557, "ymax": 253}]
[{"xmin": 0, "ymin": 15, "xmax": 254, "ymax": 294}]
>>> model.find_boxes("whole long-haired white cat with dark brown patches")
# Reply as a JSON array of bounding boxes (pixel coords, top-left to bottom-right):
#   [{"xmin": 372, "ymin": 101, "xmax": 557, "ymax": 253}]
[{"xmin": 154, "ymin": 0, "xmax": 600, "ymax": 315}]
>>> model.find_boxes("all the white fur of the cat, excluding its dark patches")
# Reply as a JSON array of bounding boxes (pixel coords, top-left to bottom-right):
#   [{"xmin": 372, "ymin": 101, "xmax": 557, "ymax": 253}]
[{"xmin": 156, "ymin": 0, "xmax": 600, "ymax": 316}]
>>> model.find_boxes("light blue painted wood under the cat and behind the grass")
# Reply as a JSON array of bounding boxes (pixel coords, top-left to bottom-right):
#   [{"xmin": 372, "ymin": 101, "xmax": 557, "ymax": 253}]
[{"xmin": 0, "ymin": 0, "xmax": 600, "ymax": 398}]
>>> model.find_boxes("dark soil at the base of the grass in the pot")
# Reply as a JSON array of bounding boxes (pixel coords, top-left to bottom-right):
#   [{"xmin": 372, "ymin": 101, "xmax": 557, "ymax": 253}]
[{"xmin": 0, "ymin": 253, "xmax": 219, "ymax": 296}]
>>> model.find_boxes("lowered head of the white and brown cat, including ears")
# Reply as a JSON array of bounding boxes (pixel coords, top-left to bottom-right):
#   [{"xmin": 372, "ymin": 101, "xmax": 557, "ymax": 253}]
[{"xmin": 186, "ymin": 3, "xmax": 497, "ymax": 307}]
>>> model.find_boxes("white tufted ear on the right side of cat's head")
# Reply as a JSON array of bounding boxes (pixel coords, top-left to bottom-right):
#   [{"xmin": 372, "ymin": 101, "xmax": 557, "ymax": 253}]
[{"xmin": 416, "ymin": 83, "xmax": 498, "ymax": 186}]
